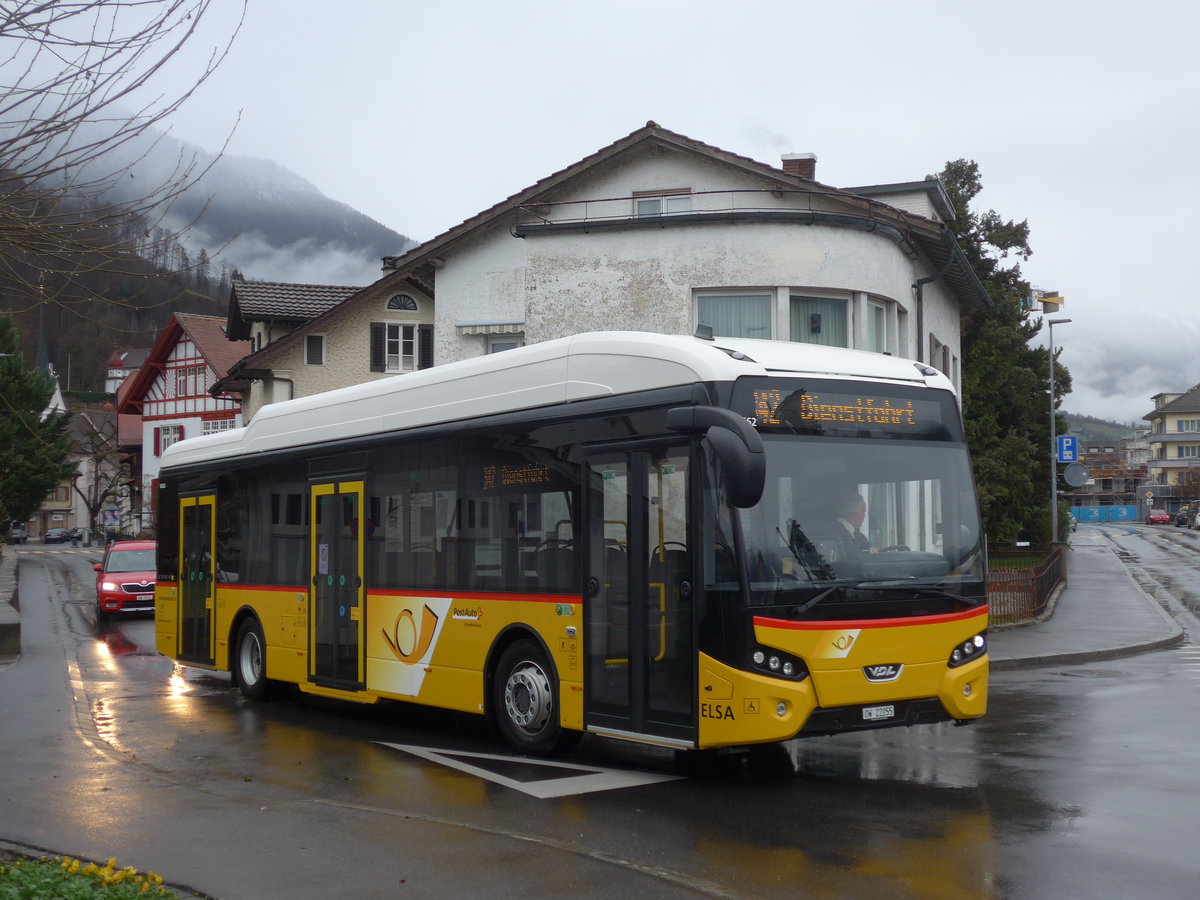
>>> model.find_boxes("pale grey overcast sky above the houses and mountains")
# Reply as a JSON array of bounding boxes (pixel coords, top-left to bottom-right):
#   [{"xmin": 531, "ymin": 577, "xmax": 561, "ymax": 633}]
[{"xmin": 154, "ymin": 0, "xmax": 1200, "ymax": 424}]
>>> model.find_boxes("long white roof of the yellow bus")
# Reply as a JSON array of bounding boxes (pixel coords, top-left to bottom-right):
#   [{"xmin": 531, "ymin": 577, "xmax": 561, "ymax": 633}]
[{"xmin": 162, "ymin": 331, "xmax": 953, "ymax": 468}]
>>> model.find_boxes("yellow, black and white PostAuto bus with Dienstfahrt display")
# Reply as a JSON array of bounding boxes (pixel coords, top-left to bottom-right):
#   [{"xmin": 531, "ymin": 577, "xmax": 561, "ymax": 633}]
[{"xmin": 155, "ymin": 332, "xmax": 988, "ymax": 754}]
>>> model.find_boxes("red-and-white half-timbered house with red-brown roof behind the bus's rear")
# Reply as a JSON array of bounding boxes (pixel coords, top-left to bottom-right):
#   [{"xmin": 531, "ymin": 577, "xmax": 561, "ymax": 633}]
[{"xmin": 118, "ymin": 313, "xmax": 250, "ymax": 518}]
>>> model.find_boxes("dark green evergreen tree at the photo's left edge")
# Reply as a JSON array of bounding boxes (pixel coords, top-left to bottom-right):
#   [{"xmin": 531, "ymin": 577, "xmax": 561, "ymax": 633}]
[{"xmin": 0, "ymin": 316, "xmax": 74, "ymax": 522}]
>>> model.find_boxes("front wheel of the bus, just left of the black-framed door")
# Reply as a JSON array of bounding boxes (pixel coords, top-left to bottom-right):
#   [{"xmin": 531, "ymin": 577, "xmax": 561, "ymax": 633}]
[{"xmin": 492, "ymin": 638, "xmax": 574, "ymax": 755}]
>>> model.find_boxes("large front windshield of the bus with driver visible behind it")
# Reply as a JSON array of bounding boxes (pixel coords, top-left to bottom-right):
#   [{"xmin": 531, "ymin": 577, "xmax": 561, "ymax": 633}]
[{"xmin": 737, "ymin": 434, "xmax": 984, "ymax": 605}]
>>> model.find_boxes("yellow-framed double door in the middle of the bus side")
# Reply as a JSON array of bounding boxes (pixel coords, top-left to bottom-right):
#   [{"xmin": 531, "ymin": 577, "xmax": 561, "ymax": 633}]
[{"xmin": 308, "ymin": 481, "xmax": 367, "ymax": 690}]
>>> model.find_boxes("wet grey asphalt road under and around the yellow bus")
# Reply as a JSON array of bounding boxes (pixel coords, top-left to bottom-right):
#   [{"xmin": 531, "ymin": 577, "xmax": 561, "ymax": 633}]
[{"xmin": 0, "ymin": 526, "xmax": 1200, "ymax": 900}]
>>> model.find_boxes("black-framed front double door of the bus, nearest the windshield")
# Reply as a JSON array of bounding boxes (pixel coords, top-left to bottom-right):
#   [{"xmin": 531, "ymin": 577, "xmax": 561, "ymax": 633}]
[{"xmin": 584, "ymin": 445, "xmax": 696, "ymax": 746}]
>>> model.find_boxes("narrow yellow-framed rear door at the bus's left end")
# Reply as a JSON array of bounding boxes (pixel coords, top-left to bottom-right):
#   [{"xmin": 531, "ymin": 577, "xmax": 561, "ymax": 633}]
[{"xmin": 179, "ymin": 494, "xmax": 216, "ymax": 666}]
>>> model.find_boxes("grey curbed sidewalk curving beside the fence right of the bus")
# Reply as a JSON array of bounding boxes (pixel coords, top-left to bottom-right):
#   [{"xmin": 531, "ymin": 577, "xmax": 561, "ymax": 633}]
[{"xmin": 988, "ymin": 540, "xmax": 1186, "ymax": 670}]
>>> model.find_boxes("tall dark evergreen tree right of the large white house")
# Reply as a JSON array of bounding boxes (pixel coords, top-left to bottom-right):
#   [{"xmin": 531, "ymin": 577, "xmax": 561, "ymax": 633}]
[{"xmin": 938, "ymin": 160, "xmax": 1070, "ymax": 541}]
